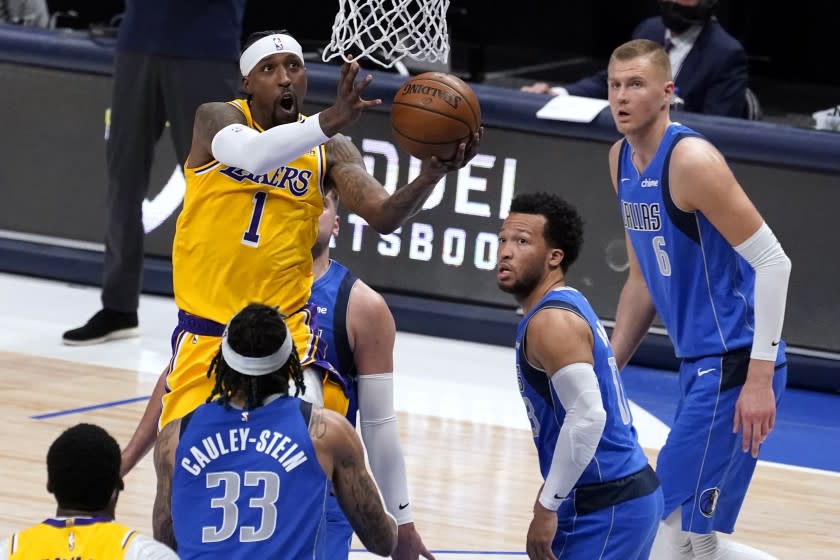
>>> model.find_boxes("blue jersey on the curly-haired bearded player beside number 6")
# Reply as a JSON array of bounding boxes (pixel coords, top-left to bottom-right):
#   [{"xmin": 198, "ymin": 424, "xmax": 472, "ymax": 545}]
[{"xmin": 516, "ymin": 287, "xmax": 648, "ymax": 487}]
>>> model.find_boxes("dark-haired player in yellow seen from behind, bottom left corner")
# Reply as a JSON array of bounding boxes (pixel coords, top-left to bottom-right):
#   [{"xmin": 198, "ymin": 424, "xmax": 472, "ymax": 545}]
[{"xmin": 0, "ymin": 424, "xmax": 178, "ymax": 560}]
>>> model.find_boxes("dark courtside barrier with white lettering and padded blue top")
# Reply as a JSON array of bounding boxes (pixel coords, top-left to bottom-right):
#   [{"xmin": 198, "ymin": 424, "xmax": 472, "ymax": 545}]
[{"xmin": 0, "ymin": 26, "xmax": 840, "ymax": 390}]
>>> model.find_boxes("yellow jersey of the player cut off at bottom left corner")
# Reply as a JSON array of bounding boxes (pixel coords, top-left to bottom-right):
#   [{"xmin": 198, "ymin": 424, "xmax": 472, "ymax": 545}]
[{"xmin": 8, "ymin": 517, "xmax": 137, "ymax": 560}]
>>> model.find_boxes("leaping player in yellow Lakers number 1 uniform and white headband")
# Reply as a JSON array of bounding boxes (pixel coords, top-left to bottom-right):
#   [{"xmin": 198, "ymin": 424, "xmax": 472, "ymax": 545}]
[{"xmin": 122, "ymin": 26, "xmax": 481, "ymax": 540}]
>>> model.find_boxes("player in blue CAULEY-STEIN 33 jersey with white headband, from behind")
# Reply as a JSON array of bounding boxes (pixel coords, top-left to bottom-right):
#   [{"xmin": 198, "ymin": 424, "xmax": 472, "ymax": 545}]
[{"xmin": 154, "ymin": 304, "xmax": 397, "ymax": 560}]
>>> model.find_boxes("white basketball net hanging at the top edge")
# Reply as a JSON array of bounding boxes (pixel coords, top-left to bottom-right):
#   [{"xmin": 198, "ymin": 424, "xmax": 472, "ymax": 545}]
[{"xmin": 323, "ymin": 0, "xmax": 449, "ymax": 68}]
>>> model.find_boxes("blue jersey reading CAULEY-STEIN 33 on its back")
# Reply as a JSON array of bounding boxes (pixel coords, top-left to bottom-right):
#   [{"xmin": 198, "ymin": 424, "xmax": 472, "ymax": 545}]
[{"xmin": 172, "ymin": 397, "xmax": 328, "ymax": 560}]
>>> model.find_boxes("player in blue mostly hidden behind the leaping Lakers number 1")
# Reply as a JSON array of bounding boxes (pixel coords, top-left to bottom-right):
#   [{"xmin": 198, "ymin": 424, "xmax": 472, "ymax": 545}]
[{"xmin": 309, "ymin": 183, "xmax": 434, "ymax": 560}]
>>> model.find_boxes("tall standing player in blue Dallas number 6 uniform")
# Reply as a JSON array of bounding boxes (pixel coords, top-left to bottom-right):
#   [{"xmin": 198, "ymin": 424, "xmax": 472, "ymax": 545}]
[{"xmin": 608, "ymin": 40, "xmax": 791, "ymax": 559}]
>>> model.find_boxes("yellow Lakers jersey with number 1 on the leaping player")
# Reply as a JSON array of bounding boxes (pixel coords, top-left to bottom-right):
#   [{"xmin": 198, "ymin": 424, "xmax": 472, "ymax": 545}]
[{"xmin": 172, "ymin": 99, "xmax": 326, "ymax": 324}]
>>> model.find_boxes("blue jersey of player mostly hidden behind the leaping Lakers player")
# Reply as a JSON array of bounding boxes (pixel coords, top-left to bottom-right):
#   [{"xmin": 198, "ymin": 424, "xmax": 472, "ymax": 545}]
[{"xmin": 309, "ymin": 260, "xmax": 359, "ymax": 426}]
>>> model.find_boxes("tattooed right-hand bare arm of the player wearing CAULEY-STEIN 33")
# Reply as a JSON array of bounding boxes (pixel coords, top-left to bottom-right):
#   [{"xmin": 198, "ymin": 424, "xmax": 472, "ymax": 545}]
[{"xmin": 309, "ymin": 407, "xmax": 397, "ymax": 556}]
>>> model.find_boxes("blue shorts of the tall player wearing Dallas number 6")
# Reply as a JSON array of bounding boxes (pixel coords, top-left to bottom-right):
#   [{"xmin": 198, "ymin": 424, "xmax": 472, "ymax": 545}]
[{"xmin": 656, "ymin": 347, "xmax": 787, "ymax": 534}]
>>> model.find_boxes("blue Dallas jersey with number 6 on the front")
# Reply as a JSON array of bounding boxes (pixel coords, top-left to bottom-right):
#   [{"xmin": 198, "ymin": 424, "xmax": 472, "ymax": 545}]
[{"xmin": 617, "ymin": 123, "xmax": 755, "ymax": 358}]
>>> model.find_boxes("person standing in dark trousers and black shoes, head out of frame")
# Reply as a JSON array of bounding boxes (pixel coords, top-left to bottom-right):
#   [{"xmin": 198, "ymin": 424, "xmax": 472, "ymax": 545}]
[{"xmin": 62, "ymin": 0, "xmax": 246, "ymax": 345}]
